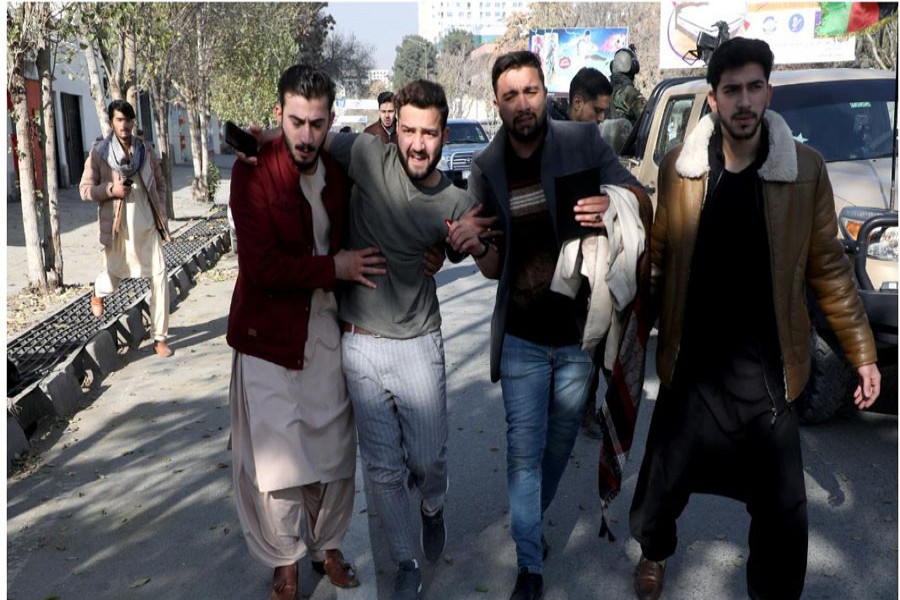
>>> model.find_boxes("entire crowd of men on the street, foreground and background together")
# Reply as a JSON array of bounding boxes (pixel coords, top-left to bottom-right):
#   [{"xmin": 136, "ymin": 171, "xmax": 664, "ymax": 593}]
[{"xmin": 81, "ymin": 38, "xmax": 880, "ymax": 600}]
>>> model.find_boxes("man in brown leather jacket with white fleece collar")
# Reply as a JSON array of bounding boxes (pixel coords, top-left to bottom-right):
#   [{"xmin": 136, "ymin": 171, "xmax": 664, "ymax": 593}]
[{"xmin": 631, "ymin": 38, "xmax": 881, "ymax": 600}]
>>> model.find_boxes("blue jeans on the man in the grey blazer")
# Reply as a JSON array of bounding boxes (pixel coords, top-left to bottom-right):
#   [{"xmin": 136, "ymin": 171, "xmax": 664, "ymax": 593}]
[{"xmin": 500, "ymin": 335, "xmax": 594, "ymax": 573}]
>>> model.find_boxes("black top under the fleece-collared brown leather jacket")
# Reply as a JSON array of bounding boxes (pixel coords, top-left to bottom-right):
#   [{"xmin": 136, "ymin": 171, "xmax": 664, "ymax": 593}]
[{"xmin": 680, "ymin": 128, "xmax": 778, "ymax": 399}]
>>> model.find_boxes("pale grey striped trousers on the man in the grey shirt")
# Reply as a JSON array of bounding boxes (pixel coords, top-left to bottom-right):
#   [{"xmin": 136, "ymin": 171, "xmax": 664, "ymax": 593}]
[{"xmin": 341, "ymin": 330, "xmax": 447, "ymax": 563}]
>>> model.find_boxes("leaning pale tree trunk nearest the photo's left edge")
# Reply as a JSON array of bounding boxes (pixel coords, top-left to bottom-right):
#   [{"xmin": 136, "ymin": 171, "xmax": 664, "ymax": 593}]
[{"xmin": 7, "ymin": 61, "xmax": 47, "ymax": 292}]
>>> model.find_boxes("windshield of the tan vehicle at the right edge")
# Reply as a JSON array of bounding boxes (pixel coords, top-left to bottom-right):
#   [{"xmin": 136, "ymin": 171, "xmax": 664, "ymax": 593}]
[{"xmin": 771, "ymin": 79, "xmax": 896, "ymax": 162}]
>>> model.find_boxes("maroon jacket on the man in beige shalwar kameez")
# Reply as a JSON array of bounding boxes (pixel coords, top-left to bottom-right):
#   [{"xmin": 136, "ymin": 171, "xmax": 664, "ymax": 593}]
[{"xmin": 227, "ymin": 140, "xmax": 349, "ymax": 369}]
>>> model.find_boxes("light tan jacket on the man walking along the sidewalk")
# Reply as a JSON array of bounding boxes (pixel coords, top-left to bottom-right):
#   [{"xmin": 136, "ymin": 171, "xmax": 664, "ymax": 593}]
[{"xmin": 79, "ymin": 135, "xmax": 169, "ymax": 247}]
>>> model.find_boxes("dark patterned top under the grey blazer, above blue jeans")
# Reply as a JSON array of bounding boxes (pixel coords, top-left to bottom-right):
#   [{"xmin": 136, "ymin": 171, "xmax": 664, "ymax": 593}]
[{"xmin": 506, "ymin": 142, "xmax": 581, "ymax": 347}]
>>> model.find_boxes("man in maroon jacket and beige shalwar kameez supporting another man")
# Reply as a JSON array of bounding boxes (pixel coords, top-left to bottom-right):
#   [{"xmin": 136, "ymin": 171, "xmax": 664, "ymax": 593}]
[{"xmin": 227, "ymin": 65, "xmax": 385, "ymax": 600}]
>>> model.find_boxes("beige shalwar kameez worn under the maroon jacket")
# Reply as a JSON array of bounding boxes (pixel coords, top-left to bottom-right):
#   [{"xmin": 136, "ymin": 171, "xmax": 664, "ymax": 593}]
[{"xmin": 230, "ymin": 158, "xmax": 356, "ymax": 568}]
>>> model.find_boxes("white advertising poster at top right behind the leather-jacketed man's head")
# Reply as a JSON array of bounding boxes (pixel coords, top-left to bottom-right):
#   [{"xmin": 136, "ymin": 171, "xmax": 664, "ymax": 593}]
[{"xmin": 659, "ymin": 0, "xmax": 856, "ymax": 69}]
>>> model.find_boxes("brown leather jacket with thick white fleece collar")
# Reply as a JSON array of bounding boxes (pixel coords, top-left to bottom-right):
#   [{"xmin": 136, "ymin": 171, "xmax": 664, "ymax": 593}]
[{"xmin": 651, "ymin": 111, "xmax": 876, "ymax": 399}]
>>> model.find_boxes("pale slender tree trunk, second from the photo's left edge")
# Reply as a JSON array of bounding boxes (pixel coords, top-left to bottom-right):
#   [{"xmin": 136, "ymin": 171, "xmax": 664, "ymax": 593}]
[{"xmin": 36, "ymin": 45, "xmax": 63, "ymax": 289}]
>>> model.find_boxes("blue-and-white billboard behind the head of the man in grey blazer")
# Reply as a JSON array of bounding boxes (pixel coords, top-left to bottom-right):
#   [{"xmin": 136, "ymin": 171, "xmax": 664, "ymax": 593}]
[{"xmin": 528, "ymin": 27, "xmax": 628, "ymax": 94}]
